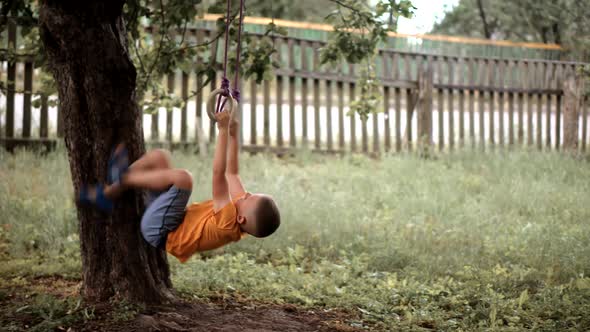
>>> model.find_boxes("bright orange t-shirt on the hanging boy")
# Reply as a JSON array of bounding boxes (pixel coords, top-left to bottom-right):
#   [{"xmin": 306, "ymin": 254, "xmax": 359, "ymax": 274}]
[{"xmin": 166, "ymin": 197, "xmax": 242, "ymax": 263}]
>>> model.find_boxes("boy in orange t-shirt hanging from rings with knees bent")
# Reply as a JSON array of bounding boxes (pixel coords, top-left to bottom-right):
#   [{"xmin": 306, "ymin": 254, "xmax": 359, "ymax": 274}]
[{"xmin": 80, "ymin": 112, "xmax": 280, "ymax": 263}]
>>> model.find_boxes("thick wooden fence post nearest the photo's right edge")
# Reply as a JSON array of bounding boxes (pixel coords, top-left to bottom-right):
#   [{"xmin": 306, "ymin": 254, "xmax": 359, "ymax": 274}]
[{"xmin": 563, "ymin": 74, "xmax": 584, "ymax": 152}]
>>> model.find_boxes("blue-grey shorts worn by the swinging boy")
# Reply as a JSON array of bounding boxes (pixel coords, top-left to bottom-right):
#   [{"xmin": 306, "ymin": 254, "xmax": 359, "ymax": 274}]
[{"xmin": 141, "ymin": 186, "xmax": 191, "ymax": 249}]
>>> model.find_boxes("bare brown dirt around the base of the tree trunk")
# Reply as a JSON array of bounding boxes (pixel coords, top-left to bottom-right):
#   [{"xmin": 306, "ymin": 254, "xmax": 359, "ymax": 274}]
[{"xmin": 0, "ymin": 278, "xmax": 368, "ymax": 332}]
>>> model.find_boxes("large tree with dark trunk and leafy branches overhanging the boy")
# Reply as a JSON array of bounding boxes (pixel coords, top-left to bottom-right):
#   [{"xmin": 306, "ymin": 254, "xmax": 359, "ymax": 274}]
[{"xmin": 0, "ymin": 0, "xmax": 411, "ymax": 302}]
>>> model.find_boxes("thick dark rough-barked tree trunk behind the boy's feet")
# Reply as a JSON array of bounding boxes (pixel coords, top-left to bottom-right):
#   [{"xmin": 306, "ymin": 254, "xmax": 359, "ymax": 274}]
[{"xmin": 39, "ymin": 0, "xmax": 172, "ymax": 303}]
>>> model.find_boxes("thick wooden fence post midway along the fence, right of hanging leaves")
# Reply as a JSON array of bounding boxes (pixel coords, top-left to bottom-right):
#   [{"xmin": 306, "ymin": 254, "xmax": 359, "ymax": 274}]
[{"xmin": 418, "ymin": 64, "xmax": 434, "ymax": 157}]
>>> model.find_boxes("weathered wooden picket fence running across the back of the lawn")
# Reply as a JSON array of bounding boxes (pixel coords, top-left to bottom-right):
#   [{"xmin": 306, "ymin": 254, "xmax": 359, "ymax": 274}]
[{"xmin": 0, "ymin": 25, "xmax": 589, "ymax": 153}]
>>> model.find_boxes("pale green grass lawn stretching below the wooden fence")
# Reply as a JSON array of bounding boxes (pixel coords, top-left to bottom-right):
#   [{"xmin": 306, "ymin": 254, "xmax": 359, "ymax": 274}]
[{"xmin": 0, "ymin": 151, "xmax": 590, "ymax": 331}]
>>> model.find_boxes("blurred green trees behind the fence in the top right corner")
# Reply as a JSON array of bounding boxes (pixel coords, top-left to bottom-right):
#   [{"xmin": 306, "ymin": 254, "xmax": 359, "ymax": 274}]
[{"xmin": 432, "ymin": 0, "xmax": 590, "ymax": 60}]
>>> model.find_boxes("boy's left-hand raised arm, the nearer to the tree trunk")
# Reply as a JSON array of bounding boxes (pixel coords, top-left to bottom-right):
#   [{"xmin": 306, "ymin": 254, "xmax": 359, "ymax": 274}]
[{"xmin": 213, "ymin": 112, "xmax": 231, "ymax": 212}]
